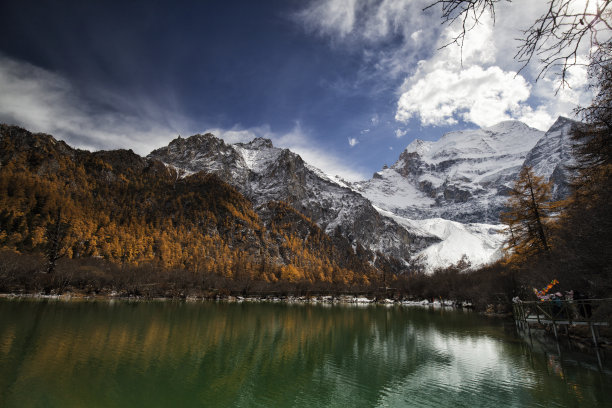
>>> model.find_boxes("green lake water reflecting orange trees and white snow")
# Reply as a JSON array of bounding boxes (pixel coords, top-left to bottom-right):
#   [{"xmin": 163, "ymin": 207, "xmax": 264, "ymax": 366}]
[{"xmin": 0, "ymin": 300, "xmax": 612, "ymax": 408}]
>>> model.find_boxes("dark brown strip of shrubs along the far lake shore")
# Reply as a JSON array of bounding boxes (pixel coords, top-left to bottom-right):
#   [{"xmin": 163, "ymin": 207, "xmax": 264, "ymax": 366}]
[{"xmin": 0, "ymin": 250, "xmax": 524, "ymax": 315}]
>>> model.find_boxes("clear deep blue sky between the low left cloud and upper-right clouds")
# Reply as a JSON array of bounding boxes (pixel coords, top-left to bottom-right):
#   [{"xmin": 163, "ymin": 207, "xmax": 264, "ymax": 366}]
[{"xmin": 0, "ymin": 0, "xmax": 466, "ymax": 175}]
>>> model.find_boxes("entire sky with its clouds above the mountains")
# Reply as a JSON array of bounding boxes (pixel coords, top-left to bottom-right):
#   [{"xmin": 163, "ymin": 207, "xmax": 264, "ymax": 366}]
[{"xmin": 0, "ymin": 0, "xmax": 591, "ymax": 181}]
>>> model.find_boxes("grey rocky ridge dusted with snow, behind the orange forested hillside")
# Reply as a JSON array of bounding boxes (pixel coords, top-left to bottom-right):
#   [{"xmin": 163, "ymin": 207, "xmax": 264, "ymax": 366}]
[{"xmin": 149, "ymin": 134, "xmax": 438, "ymax": 261}]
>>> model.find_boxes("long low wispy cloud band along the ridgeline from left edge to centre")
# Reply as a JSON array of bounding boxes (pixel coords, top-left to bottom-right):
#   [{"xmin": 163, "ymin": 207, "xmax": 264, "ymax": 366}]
[{"xmin": 0, "ymin": 55, "xmax": 365, "ymax": 180}]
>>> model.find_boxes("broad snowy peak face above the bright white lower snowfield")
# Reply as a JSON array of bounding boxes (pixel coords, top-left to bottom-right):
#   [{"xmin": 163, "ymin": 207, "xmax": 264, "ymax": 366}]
[{"xmin": 353, "ymin": 121, "xmax": 544, "ymax": 223}]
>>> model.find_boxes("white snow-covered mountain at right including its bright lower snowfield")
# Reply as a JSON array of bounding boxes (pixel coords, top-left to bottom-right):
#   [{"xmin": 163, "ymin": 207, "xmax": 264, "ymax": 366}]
[{"xmin": 352, "ymin": 117, "xmax": 577, "ymax": 270}]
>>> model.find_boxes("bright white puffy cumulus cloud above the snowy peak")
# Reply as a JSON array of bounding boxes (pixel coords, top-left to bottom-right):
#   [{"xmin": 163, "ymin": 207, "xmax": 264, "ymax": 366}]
[{"xmin": 395, "ymin": 6, "xmax": 590, "ymax": 130}]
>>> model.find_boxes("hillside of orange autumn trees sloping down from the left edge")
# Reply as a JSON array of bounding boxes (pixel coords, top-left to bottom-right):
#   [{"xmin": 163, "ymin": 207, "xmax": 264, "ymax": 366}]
[{"xmin": 0, "ymin": 125, "xmax": 384, "ymax": 291}]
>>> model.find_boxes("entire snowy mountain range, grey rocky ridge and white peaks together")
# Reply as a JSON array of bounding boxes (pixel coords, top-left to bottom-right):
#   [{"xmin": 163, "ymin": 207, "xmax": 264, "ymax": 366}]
[{"xmin": 149, "ymin": 118, "xmax": 576, "ymax": 270}]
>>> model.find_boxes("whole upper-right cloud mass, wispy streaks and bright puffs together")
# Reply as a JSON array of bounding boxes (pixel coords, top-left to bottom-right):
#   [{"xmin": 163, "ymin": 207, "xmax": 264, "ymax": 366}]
[{"xmin": 298, "ymin": 0, "xmax": 591, "ymax": 129}]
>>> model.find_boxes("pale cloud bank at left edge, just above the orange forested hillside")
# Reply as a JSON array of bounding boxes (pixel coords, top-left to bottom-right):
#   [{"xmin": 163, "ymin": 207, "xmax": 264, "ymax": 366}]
[{"xmin": 0, "ymin": 55, "xmax": 190, "ymax": 154}]
